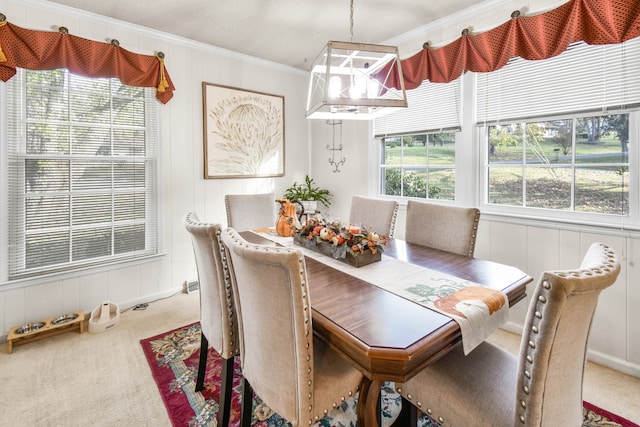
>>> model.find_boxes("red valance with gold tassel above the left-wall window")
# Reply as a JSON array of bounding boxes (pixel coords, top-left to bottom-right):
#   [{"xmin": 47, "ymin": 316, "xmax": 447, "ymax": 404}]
[{"xmin": 0, "ymin": 14, "xmax": 175, "ymax": 104}]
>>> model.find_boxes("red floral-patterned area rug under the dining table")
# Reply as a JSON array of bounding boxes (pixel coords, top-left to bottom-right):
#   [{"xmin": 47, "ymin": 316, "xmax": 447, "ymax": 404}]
[{"xmin": 140, "ymin": 323, "xmax": 640, "ymax": 427}]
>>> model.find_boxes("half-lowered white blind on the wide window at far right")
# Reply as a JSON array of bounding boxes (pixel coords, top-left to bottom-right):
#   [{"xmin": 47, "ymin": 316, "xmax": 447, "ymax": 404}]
[{"xmin": 476, "ymin": 38, "xmax": 640, "ymax": 124}]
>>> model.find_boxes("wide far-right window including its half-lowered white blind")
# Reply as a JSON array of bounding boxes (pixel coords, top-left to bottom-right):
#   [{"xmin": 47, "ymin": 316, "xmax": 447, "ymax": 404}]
[{"xmin": 476, "ymin": 34, "xmax": 640, "ymax": 225}]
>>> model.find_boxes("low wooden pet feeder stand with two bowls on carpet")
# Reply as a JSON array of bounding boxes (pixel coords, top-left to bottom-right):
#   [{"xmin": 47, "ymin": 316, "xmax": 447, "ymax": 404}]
[{"xmin": 7, "ymin": 310, "xmax": 84, "ymax": 353}]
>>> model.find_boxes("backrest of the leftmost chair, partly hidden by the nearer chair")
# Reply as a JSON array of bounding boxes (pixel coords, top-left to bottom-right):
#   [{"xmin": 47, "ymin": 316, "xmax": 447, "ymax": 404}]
[{"xmin": 183, "ymin": 212, "xmax": 239, "ymax": 359}]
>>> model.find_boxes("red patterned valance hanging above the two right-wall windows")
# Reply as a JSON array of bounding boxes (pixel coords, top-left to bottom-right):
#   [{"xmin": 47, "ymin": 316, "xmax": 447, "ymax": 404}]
[{"xmin": 381, "ymin": 0, "xmax": 640, "ymax": 89}]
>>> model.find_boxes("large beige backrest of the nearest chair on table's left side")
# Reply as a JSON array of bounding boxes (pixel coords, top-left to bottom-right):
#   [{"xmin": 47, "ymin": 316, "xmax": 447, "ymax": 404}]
[{"xmin": 222, "ymin": 229, "xmax": 314, "ymax": 425}]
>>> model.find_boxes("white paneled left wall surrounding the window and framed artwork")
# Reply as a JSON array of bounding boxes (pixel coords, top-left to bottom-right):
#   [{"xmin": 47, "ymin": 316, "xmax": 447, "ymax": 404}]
[{"xmin": 0, "ymin": 0, "xmax": 310, "ymax": 337}]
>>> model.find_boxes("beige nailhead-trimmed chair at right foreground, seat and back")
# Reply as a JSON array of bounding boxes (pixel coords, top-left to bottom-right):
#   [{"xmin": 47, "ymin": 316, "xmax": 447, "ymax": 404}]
[{"xmin": 396, "ymin": 243, "xmax": 620, "ymax": 427}]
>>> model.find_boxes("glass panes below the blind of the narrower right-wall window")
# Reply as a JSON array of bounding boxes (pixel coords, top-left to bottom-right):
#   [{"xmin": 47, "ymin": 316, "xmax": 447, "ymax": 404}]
[{"xmin": 380, "ymin": 132, "xmax": 456, "ymax": 200}]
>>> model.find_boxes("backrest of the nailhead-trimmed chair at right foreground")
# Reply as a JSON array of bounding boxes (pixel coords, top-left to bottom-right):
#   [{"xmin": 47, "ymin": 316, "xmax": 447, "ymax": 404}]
[{"xmin": 515, "ymin": 243, "xmax": 620, "ymax": 426}]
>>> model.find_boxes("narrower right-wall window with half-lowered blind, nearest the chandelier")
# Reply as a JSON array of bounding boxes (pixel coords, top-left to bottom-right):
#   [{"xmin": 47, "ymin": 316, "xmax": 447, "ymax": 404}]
[{"xmin": 374, "ymin": 79, "xmax": 461, "ymax": 200}]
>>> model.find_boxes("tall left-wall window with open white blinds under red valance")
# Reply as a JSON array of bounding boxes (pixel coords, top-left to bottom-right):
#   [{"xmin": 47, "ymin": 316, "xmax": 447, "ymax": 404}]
[{"xmin": 5, "ymin": 69, "xmax": 158, "ymax": 280}]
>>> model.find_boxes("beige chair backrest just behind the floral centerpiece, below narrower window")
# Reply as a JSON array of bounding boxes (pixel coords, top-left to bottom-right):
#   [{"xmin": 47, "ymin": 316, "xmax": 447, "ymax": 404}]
[{"xmin": 349, "ymin": 196, "xmax": 398, "ymax": 237}]
